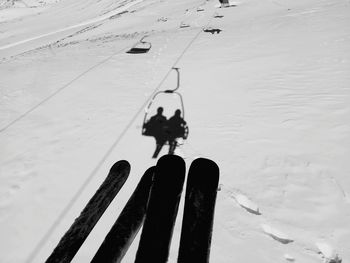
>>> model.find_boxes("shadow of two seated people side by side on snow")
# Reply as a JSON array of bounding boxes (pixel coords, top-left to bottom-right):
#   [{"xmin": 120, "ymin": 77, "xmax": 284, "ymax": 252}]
[{"xmin": 143, "ymin": 107, "xmax": 188, "ymax": 158}]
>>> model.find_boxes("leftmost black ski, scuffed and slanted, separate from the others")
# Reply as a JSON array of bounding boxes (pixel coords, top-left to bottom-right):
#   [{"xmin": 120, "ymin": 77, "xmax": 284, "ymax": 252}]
[{"xmin": 46, "ymin": 160, "xmax": 130, "ymax": 263}]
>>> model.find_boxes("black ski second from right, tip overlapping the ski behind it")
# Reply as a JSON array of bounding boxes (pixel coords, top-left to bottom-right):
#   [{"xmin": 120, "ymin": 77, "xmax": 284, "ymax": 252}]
[{"xmin": 135, "ymin": 155, "xmax": 185, "ymax": 263}]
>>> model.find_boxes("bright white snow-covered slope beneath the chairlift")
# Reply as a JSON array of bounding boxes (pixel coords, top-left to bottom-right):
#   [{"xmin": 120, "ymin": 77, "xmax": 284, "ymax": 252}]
[{"xmin": 0, "ymin": 0, "xmax": 350, "ymax": 263}]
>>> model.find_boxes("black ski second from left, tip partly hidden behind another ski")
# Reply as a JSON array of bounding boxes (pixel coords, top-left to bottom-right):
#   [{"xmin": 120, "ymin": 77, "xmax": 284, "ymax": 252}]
[{"xmin": 91, "ymin": 167, "xmax": 155, "ymax": 263}]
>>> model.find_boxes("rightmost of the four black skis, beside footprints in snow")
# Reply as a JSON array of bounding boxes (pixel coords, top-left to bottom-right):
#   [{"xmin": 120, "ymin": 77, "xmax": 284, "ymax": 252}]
[{"xmin": 178, "ymin": 158, "xmax": 219, "ymax": 263}]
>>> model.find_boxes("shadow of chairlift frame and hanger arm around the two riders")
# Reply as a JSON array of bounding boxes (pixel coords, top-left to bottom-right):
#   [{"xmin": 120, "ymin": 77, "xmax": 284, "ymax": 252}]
[{"xmin": 142, "ymin": 68, "xmax": 188, "ymax": 140}]
